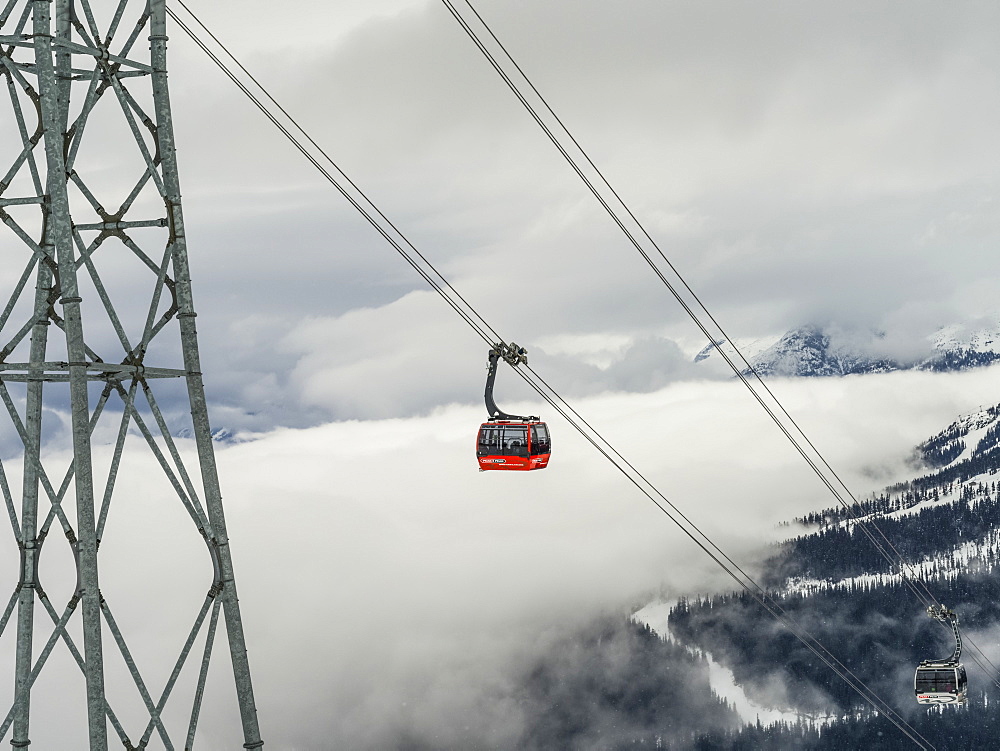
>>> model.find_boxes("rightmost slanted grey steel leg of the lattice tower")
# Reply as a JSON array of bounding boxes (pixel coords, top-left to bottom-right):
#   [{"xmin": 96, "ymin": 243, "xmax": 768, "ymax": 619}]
[{"xmin": 149, "ymin": 0, "xmax": 264, "ymax": 749}]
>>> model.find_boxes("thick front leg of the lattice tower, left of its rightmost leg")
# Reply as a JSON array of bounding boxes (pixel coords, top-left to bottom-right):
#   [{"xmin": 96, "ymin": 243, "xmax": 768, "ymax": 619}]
[{"xmin": 32, "ymin": 0, "xmax": 108, "ymax": 751}]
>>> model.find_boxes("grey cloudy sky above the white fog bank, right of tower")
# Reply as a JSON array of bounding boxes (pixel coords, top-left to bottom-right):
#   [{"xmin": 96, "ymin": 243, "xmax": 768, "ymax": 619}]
[{"xmin": 145, "ymin": 0, "xmax": 1000, "ymax": 428}]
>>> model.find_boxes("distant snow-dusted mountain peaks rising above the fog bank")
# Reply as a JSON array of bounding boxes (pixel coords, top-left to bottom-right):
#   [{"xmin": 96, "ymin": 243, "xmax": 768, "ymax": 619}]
[{"xmin": 694, "ymin": 316, "xmax": 1000, "ymax": 377}]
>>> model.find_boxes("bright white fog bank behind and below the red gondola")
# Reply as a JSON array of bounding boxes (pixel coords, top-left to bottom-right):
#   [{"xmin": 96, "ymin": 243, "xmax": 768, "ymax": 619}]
[{"xmin": 209, "ymin": 369, "xmax": 996, "ymax": 749}]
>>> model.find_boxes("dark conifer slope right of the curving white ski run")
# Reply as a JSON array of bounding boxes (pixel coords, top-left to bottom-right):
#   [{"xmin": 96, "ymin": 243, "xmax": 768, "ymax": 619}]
[{"xmin": 669, "ymin": 407, "xmax": 1000, "ymax": 749}]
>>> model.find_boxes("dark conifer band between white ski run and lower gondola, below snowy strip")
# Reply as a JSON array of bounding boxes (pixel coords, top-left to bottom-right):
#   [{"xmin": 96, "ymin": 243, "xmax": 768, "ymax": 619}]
[{"xmin": 670, "ymin": 573, "xmax": 1000, "ymax": 713}]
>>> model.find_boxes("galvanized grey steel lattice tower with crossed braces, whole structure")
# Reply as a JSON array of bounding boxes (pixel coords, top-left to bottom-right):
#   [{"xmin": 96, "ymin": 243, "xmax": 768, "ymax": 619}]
[{"xmin": 0, "ymin": 0, "xmax": 263, "ymax": 749}]
